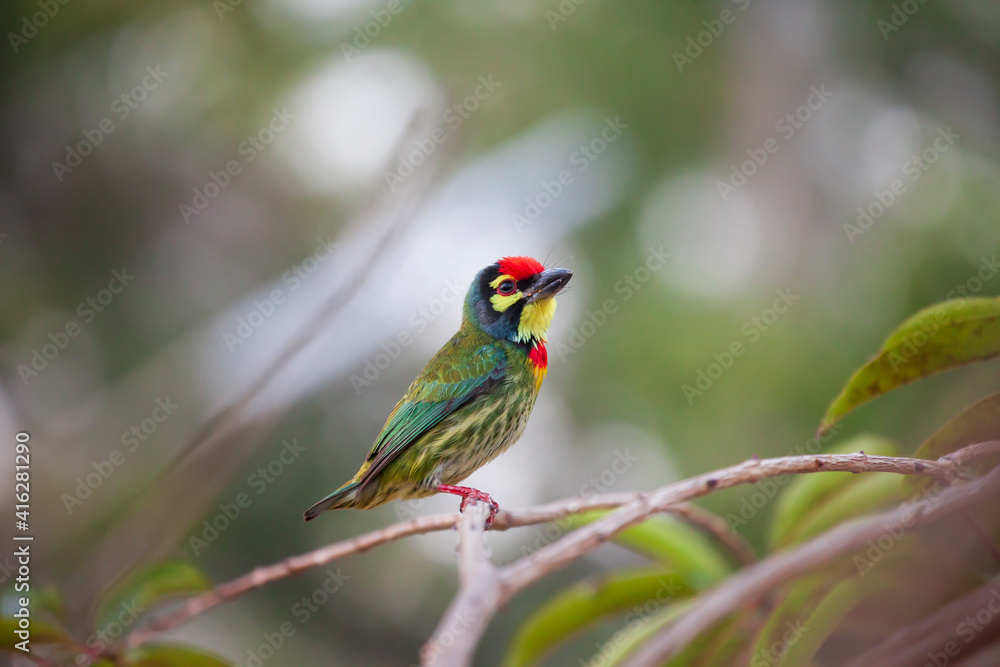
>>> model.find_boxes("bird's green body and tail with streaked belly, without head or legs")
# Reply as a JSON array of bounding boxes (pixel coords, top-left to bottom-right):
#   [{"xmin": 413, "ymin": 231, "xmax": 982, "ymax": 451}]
[{"xmin": 332, "ymin": 321, "xmax": 538, "ymax": 516}]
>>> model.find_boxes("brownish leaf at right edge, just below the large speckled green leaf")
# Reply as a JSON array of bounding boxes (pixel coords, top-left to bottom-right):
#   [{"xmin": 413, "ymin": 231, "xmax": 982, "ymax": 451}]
[{"xmin": 903, "ymin": 393, "xmax": 1000, "ymax": 498}]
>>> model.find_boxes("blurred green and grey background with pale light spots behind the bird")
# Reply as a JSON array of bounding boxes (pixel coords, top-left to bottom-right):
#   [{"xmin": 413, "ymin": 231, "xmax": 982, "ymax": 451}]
[{"xmin": 0, "ymin": 0, "xmax": 1000, "ymax": 665}]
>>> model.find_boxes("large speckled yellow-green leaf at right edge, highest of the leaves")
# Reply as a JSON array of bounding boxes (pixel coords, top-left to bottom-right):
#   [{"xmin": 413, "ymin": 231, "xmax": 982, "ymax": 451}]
[{"xmin": 819, "ymin": 297, "xmax": 1000, "ymax": 433}]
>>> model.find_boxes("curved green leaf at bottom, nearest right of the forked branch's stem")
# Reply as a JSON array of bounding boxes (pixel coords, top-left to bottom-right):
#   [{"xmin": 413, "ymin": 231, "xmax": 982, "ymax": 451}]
[{"xmin": 503, "ymin": 568, "xmax": 693, "ymax": 667}]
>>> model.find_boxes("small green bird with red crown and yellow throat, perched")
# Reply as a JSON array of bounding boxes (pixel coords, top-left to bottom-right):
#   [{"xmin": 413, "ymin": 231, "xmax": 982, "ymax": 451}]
[{"xmin": 304, "ymin": 256, "xmax": 573, "ymax": 527}]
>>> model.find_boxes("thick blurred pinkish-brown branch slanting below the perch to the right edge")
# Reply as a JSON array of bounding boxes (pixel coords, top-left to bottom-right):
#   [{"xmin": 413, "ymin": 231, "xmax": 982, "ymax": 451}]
[{"xmin": 625, "ymin": 468, "xmax": 1000, "ymax": 667}]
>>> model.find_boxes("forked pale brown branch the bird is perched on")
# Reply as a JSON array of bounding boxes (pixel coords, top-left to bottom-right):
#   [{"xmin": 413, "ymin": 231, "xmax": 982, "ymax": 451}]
[{"xmin": 123, "ymin": 441, "xmax": 1000, "ymax": 665}]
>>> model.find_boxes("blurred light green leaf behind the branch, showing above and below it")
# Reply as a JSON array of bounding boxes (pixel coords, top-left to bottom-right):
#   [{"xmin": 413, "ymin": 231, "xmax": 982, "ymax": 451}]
[{"xmin": 769, "ymin": 434, "xmax": 899, "ymax": 545}]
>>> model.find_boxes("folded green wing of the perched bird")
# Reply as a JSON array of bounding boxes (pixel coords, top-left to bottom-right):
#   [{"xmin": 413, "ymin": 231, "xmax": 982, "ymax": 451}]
[{"xmin": 360, "ymin": 343, "xmax": 507, "ymax": 487}]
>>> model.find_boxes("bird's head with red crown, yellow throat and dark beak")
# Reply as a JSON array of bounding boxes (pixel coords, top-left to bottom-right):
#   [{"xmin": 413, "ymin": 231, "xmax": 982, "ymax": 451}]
[{"xmin": 465, "ymin": 257, "xmax": 573, "ymax": 347}]
